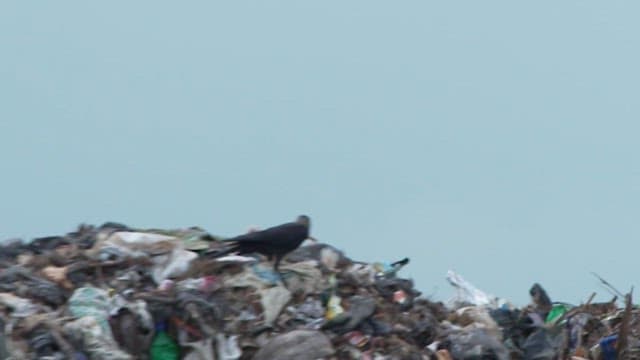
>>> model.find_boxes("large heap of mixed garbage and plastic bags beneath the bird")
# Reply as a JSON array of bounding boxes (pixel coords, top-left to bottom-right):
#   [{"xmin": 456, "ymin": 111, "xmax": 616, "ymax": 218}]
[{"xmin": 0, "ymin": 223, "xmax": 640, "ymax": 360}]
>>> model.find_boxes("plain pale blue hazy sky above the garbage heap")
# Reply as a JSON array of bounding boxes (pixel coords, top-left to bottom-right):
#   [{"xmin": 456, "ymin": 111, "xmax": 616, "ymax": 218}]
[{"xmin": 0, "ymin": 1, "xmax": 640, "ymax": 304}]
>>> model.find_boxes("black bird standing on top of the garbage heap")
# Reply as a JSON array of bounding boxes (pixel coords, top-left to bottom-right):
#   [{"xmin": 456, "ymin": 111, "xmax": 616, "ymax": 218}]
[{"xmin": 207, "ymin": 215, "xmax": 315, "ymax": 272}]
